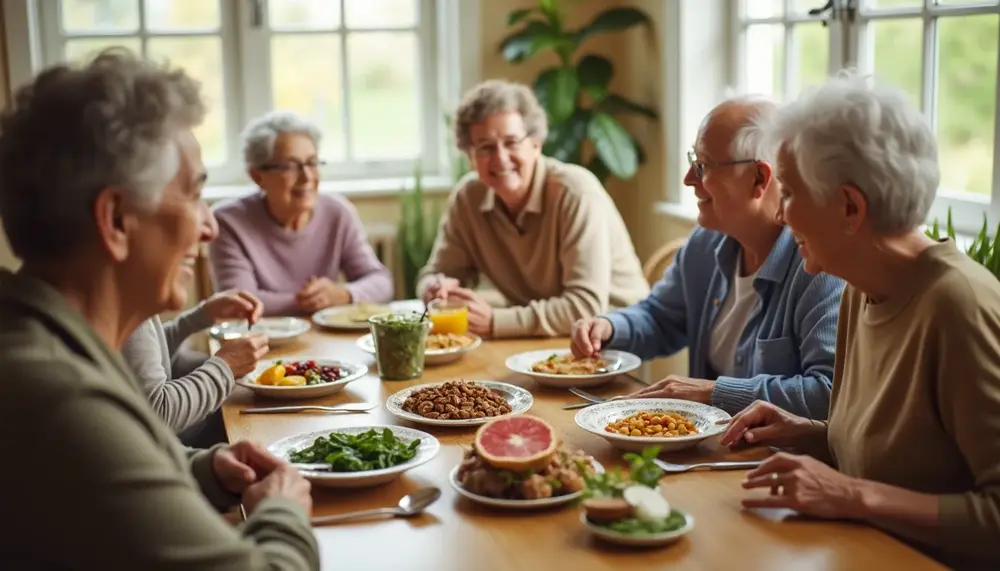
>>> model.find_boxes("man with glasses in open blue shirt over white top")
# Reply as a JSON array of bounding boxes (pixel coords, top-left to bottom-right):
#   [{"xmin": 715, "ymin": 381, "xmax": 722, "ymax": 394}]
[{"xmin": 572, "ymin": 96, "xmax": 843, "ymax": 419}]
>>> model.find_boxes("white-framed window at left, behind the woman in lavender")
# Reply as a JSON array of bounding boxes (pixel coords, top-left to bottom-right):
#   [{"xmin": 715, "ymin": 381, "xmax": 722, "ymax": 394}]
[{"xmin": 8, "ymin": 0, "xmax": 470, "ymax": 194}]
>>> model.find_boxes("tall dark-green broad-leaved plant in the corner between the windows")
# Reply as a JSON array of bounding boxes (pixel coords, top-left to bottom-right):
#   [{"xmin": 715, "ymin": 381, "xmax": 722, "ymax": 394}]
[{"xmin": 500, "ymin": 0, "xmax": 657, "ymax": 182}]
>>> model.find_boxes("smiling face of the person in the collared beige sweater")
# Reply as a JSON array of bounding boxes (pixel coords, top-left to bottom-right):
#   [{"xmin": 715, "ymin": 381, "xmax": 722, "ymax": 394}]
[{"xmin": 469, "ymin": 111, "xmax": 542, "ymax": 202}]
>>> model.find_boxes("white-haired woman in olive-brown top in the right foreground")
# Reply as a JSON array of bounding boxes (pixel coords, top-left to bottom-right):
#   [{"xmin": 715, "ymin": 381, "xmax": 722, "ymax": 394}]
[{"xmin": 722, "ymin": 78, "xmax": 1000, "ymax": 569}]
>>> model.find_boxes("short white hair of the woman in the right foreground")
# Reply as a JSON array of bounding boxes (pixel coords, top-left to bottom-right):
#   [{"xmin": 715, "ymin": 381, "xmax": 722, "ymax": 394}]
[{"xmin": 769, "ymin": 73, "xmax": 941, "ymax": 234}]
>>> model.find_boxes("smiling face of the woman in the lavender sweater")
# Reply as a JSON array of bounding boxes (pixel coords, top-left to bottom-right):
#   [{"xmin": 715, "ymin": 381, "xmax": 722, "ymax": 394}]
[{"xmin": 250, "ymin": 133, "xmax": 319, "ymax": 218}]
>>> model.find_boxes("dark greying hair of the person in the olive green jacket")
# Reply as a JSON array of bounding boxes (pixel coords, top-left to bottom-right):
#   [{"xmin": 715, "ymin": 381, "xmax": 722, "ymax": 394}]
[{"xmin": 0, "ymin": 48, "xmax": 205, "ymax": 260}]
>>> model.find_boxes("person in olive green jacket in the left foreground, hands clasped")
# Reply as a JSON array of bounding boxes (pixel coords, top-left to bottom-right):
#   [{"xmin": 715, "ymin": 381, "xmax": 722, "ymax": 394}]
[{"xmin": 0, "ymin": 50, "xmax": 319, "ymax": 571}]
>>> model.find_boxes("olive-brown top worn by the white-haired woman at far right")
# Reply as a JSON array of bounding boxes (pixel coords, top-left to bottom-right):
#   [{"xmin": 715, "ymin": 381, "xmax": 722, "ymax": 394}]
[{"xmin": 828, "ymin": 241, "xmax": 1000, "ymax": 569}]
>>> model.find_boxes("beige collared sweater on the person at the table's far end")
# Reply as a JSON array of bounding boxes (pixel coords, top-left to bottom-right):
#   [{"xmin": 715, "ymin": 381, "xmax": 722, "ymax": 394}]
[{"xmin": 417, "ymin": 157, "xmax": 649, "ymax": 337}]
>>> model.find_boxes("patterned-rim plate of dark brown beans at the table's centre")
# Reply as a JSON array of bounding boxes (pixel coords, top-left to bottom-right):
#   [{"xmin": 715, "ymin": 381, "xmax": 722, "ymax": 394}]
[{"xmin": 385, "ymin": 380, "xmax": 535, "ymax": 426}]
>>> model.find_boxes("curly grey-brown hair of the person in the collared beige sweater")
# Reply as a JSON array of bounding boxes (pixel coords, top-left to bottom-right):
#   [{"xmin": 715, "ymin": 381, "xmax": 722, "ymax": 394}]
[{"xmin": 455, "ymin": 79, "xmax": 549, "ymax": 151}]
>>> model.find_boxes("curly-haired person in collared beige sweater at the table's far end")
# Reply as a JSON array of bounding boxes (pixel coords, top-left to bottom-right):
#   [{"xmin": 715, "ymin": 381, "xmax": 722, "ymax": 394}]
[{"xmin": 417, "ymin": 81, "xmax": 649, "ymax": 337}]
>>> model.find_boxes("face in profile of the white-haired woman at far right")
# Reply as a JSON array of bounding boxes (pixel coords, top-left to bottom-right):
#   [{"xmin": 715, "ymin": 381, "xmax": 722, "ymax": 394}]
[{"xmin": 777, "ymin": 145, "xmax": 852, "ymax": 275}]
